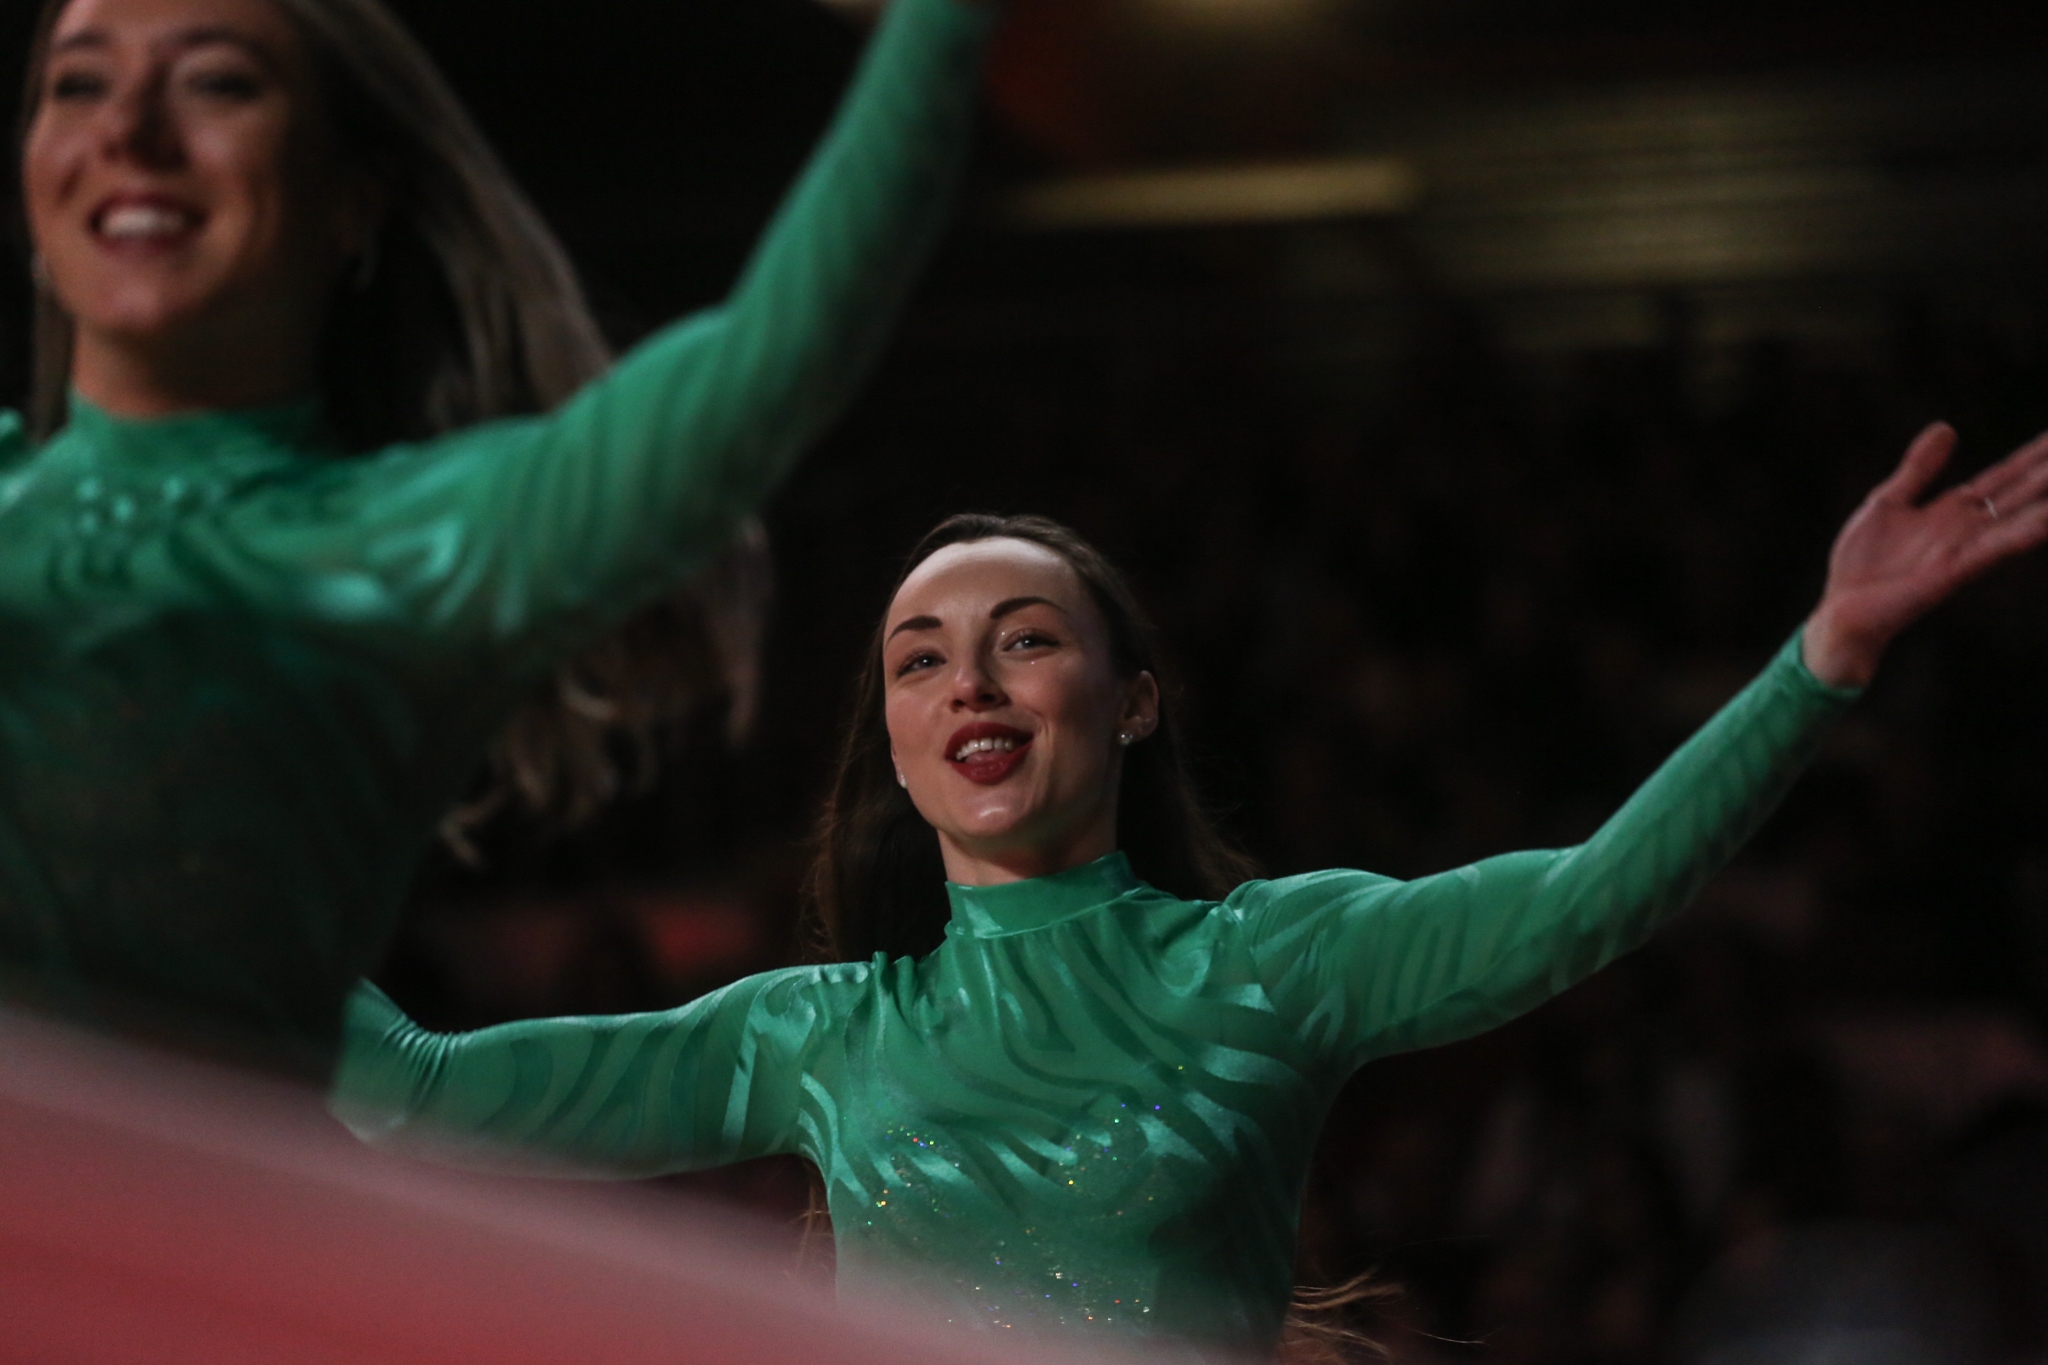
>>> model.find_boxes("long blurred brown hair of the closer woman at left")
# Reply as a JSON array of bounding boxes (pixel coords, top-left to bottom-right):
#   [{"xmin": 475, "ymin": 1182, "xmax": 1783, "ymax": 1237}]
[{"xmin": 16, "ymin": 0, "xmax": 768, "ymax": 847}]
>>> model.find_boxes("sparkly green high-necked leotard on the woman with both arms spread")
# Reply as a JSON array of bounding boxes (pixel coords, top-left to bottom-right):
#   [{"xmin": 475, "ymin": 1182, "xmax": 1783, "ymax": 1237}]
[{"xmin": 336, "ymin": 643, "xmax": 1849, "ymax": 1349}]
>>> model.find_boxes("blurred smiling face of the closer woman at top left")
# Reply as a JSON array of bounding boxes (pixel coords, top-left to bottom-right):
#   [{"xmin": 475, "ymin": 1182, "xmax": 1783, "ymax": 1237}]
[{"xmin": 23, "ymin": 0, "xmax": 381, "ymax": 415}]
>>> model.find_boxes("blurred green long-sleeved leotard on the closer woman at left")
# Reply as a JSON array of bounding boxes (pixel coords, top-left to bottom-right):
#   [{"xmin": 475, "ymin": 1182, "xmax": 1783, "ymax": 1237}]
[{"xmin": 0, "ymin": 0, "xmax": 989, "ymax": 1056}]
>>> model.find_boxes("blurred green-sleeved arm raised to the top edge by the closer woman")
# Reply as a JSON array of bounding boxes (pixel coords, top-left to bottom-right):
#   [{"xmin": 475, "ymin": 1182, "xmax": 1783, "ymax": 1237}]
[{"xmin": 238, "ymin": 0, "xmax": 993, "ymax": 653}]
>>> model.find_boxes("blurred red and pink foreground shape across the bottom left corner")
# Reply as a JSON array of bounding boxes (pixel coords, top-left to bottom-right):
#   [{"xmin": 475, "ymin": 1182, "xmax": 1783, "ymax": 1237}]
[{"xmin": 0, "ymin": 1011, "xmax": 1138, "ymax": 1365}]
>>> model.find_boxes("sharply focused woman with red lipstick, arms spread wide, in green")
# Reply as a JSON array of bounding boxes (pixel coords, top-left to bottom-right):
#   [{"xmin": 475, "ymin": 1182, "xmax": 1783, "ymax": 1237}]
[{"xmin": 336, "ymin": 428, "xmax": 2048, "ymax": 1351}]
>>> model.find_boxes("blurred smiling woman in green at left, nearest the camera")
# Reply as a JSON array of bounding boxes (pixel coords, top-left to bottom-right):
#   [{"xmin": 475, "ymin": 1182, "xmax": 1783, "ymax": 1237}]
[{"xmin": 0, "ymin": 0, "xmax": 991, "ymax": 1068}]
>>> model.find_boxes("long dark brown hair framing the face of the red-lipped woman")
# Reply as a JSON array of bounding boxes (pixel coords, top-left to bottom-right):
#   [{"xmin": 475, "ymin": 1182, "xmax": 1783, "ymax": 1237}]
[{"xmin": 807, "ymin": 512, "xmax": 1253, "ymax": 960}]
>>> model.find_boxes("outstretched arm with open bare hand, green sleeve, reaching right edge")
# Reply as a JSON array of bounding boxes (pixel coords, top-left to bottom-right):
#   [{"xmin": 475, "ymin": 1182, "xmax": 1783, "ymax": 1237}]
[{"xmin": 1233, "ymin": 426, "xmax": 2048, "ymax": 1070}]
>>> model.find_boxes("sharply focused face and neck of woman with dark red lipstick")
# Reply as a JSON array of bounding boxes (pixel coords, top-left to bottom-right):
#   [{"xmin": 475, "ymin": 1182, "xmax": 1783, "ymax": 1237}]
[{"xmin": 883, "ymin": 538, "xmax": 1159, "ymax": 886}]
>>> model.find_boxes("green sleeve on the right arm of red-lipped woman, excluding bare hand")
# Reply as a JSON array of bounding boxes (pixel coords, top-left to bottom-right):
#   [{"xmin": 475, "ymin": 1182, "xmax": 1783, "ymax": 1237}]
[{"xmin": 1231, "ymin": 639, "xmax": 1853, "ymax": 1070}]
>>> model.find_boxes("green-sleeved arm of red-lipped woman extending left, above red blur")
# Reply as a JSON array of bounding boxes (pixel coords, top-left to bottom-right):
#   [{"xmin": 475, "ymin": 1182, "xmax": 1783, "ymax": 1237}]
[{"xmin": 330, "ymin": 970, "xmax": 823, "ymax": 1177}]
